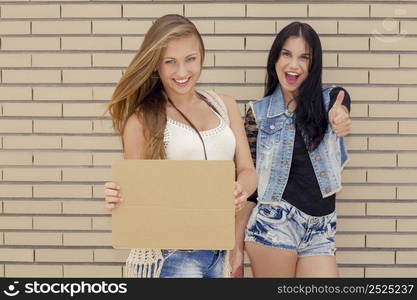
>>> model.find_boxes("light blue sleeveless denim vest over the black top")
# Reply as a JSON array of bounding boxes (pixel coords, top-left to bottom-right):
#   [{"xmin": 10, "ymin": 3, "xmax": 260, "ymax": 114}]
[{"xmin": 251, "ymin": 86, "xmax": 348, "ymax": 204}]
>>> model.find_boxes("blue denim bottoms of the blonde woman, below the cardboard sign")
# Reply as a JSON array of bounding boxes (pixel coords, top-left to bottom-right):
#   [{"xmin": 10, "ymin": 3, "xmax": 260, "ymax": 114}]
[{"xmin": 160, "ymin": 250, "xmax": 226, "ymax": 278}]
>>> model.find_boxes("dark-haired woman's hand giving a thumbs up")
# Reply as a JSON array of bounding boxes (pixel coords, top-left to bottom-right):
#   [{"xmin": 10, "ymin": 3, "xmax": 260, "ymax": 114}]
[{"xmin": 329, "ymin": 90, "xmax": 352, "ymax": 136}]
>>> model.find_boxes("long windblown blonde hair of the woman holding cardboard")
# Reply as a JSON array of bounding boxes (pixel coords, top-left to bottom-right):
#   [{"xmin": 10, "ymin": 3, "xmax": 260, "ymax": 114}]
[{"xmin": 107, "ymin": 14, "xmax": 205, "ymax": 159}]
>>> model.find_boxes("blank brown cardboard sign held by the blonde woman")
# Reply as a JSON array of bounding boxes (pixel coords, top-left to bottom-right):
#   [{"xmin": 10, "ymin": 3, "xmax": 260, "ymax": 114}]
[{"xmin": 112, "ymin": 160, "xmax": 235, "ymax": 250}]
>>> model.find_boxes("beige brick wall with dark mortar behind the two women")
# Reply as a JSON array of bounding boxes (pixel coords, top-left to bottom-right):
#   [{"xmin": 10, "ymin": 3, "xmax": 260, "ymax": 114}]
[{"xmin": 0, "ymin": 0, "xmax": 417, "ymax": 277}]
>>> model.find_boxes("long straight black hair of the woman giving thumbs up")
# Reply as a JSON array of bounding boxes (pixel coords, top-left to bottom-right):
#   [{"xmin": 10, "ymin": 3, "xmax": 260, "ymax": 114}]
[{"xmin": 265, "ymin": 22, "xmax": 328, "ymax": 151}]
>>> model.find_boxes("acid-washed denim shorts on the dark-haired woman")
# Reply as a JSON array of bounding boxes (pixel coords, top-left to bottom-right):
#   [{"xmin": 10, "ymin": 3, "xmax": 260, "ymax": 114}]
[{"xmin": 245, "ymin": 199, "xmax": 336, "ymax": 257}]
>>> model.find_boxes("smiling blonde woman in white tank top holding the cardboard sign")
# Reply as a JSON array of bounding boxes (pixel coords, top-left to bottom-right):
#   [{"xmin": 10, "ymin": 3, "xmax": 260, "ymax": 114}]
[{"xmin": 105, "ymin": 15, "xmax": 257, "ymax": 278}]
